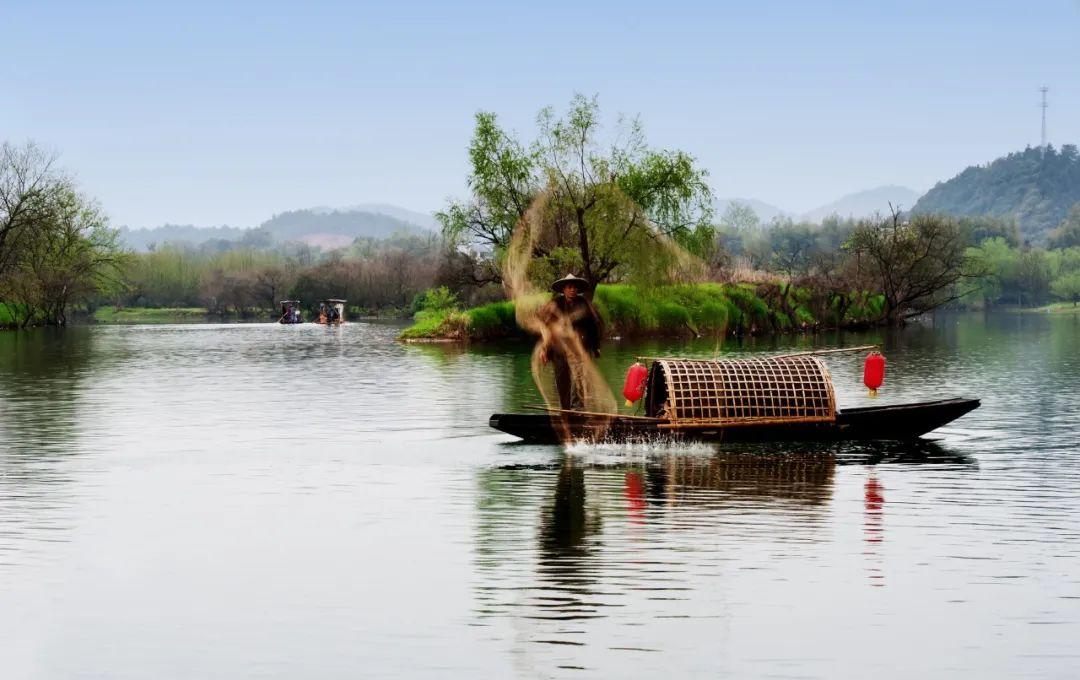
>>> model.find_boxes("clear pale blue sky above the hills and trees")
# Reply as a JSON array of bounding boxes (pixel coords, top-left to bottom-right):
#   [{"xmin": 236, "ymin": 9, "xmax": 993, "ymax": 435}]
[{"xmin": 0, "ymin": 0, "xmax": 1080, "ymax": 227}]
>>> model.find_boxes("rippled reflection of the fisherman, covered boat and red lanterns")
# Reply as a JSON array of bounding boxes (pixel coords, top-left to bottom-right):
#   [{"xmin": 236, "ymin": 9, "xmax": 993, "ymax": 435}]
[{"xmin": 474, "ymin": 441, "xmax": 974, "ymax": 650}]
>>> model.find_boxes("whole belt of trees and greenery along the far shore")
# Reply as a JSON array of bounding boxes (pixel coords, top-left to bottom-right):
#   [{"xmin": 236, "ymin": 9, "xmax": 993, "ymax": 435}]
[{"xmin": 0, "ymin": 96, "xmax": 1080, "ymax": 337}]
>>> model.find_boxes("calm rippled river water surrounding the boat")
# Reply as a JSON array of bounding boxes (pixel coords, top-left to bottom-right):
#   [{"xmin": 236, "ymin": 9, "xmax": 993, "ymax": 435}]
[{"xmin": 0, "ymin": 314, "xmax": 1080, "ymax": 678}]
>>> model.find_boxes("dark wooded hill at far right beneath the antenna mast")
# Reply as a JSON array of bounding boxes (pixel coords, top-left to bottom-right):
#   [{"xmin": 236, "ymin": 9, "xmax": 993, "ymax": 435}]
[{"xmin": 913, "ymin": 145, "xmax": 1080, "ymax": 244}]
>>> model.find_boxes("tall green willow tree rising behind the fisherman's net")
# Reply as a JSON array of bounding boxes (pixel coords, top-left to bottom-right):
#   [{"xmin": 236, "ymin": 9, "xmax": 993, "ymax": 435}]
[{"xmin": 437, "ymin": 95, "xmax": 714, "ymax": 284}]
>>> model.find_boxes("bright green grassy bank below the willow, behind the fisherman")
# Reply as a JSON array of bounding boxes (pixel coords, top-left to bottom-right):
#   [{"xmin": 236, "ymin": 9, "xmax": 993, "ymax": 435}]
[{"xmin": 401, "ymin": 283, "xmax": 882, "ymax": 341}]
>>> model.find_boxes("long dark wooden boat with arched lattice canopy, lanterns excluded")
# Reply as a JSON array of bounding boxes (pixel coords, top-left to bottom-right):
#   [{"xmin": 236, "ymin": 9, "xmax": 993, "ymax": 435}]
[{"xmin": 488, "ymin": 355, "xmax": 980, "ymax": 444}]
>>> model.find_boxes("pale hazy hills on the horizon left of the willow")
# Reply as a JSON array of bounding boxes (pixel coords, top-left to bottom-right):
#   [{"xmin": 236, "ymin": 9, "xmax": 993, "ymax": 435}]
[{"xmin": 120, "ymin": 204, "xmax": 435, "ymax": 250}]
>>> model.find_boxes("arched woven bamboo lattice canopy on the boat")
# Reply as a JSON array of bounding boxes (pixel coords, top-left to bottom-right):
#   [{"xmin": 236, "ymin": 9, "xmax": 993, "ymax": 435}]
[{"xmin": 650, "ymin": 356, "xmax": 836, "ymax": 429}]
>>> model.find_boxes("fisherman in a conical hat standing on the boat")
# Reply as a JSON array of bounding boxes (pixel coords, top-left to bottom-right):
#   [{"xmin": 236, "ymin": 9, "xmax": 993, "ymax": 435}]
[{"xmin": 539, "ymin": 274, "xmax": 604, "ymax": 410}]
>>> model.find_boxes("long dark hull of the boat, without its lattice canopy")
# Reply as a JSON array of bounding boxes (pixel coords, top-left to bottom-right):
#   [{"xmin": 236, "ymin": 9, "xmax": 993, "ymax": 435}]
[{"xmin": 488, "ymin": 399, "xmax": 978, "ymax": 444}]
